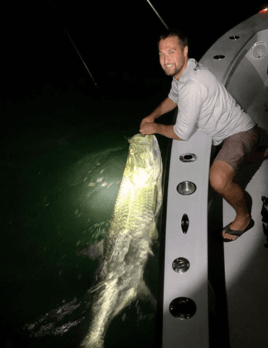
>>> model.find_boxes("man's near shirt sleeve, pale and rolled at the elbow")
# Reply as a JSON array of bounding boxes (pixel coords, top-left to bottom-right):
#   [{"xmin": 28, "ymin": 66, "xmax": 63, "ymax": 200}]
[{"xmin": 173, "ymin": 81, "xmax": 203, "ymax": 140}]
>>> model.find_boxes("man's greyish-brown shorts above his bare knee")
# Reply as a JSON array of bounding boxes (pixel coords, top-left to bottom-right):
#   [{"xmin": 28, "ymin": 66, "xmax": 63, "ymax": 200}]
[{"xmin": 214, "ymin": 125, "xmax": 260, "ymax": 173}]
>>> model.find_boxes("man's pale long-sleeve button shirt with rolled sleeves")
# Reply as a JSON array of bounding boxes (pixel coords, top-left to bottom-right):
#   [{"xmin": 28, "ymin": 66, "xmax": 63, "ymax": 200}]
[{"xmin": 168, "ymin": 59, "xmax": 256, "ymax": 145}]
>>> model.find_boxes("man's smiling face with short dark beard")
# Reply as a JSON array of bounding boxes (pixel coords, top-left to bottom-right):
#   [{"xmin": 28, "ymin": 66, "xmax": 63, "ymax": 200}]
[{"xmin": 159, "ymin": 36, "xmax": 188, "ymax": 80}]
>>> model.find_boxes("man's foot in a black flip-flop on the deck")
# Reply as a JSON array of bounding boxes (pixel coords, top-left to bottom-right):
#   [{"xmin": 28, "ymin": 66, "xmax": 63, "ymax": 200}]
[{"xmin": 222, "ymin": 216, "xmax": 254, "ymax": 242}]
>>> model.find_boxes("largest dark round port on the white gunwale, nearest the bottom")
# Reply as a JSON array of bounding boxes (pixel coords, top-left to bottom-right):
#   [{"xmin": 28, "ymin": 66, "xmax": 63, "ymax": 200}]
[{"xmin": 169, "ymin": 297, "xmax": 196, "ymax": 320}]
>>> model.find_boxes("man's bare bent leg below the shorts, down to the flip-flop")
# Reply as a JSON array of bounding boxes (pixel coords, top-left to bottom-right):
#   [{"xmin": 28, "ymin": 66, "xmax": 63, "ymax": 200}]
[{"xmin": 209, "ymin": 160, "xmax": 251, "ymax": 240}]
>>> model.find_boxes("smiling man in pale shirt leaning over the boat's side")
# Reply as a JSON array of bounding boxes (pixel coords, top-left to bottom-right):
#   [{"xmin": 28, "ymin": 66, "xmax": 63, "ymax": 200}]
[{"xmin": 140, "ymin": 30, "xmax": 268, "ymax": 242}]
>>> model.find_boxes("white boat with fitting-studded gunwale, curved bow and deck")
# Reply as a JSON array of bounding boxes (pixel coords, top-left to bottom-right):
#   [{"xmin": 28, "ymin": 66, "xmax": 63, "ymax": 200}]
[{"xmin": 162, "ymin": 8, "xmax": 268, "ymax": 348}]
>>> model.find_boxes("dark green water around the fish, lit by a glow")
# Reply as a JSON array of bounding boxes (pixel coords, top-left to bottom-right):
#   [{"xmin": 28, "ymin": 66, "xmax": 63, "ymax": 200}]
[{"xmin": 0, "ymin": 78, "xmax": 174, "ymax": 348}]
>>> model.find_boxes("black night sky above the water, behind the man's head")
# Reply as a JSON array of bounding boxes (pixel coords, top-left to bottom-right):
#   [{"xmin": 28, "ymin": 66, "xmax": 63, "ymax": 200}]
[{"xmin": 1, "ymin": 0, "xmax": 267, "ymax": 100}]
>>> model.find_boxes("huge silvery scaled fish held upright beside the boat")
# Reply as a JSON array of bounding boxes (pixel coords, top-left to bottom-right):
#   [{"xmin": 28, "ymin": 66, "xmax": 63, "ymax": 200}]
[{"xmin": 81, "ymin": 134, "xmax": 162, "ymax": 348}]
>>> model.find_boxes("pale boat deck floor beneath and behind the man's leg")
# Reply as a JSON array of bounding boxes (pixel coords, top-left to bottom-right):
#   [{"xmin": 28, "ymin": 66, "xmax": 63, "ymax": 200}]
[{"xmin": 223, "ymin": 86, "xmax": 268, "ymax": 348}]
